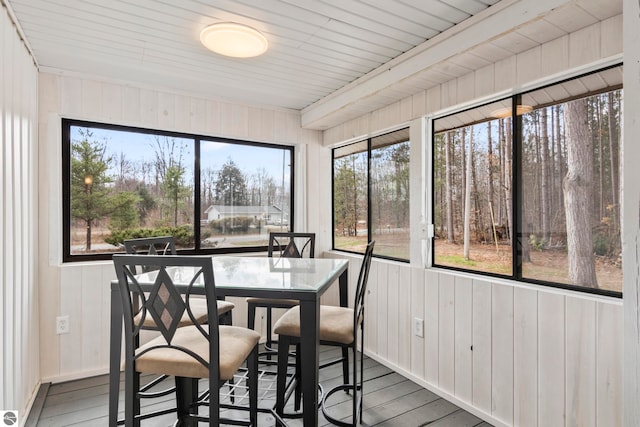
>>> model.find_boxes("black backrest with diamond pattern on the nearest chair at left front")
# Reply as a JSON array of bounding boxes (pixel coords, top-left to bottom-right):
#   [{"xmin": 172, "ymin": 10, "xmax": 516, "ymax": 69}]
[{"xmin": 113, "ymin": 254, "xmax": 219, "ymax": 372}]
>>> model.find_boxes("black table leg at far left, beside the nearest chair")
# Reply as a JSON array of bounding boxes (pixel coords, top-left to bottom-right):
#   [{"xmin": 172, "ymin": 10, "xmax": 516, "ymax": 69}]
[{"xmin": 109, "ymin": 284, "xmax": 122, "ymax": 427}]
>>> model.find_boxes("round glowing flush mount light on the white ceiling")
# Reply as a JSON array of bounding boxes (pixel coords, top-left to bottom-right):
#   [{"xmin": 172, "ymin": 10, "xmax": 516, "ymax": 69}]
[{"xmin": 200, "ymin": 22, "xmax": 269, "ymax": 58}]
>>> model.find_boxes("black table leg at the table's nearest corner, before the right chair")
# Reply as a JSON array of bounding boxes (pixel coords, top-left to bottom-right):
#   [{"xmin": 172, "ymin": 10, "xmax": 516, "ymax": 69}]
[{"xmin": 300, "ymin": 296, "xmax": 320, "ymax": 426}]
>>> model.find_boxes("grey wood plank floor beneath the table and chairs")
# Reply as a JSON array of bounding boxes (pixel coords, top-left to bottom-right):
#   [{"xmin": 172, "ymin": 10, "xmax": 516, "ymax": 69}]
[{"xmin": 26, "ymin": 348, "xmax": 491, "ymax": 427}]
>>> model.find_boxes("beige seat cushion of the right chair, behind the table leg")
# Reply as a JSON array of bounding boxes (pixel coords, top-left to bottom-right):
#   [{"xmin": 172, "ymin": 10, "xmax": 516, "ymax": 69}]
[{"xmin": 273, "ymin": 305, "xmax": 354, "ymax": 344}]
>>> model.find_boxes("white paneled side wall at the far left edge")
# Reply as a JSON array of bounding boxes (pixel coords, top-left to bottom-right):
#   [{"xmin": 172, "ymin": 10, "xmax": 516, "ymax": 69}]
[{"xmin": 0, "ymin": 1, "xmax": 40, "ymax": 416}]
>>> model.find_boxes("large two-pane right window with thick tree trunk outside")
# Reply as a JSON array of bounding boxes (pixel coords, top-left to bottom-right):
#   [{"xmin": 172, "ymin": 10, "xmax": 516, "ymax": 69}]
[{"xmin": 433, "ymin": 66, "xmax": 622, "ymax": 295}]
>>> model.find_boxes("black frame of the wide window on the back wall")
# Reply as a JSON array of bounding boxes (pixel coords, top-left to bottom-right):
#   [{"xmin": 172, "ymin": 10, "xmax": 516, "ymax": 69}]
[{"xmin": 61, "ymin": 118, "xmax": 295, "ymax": 263}]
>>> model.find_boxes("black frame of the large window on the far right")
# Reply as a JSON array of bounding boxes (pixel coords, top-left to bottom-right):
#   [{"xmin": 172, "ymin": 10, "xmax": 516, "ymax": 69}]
[{"xmin": 428, "ymin": 62, "xmax": 624, "ymax": 298}]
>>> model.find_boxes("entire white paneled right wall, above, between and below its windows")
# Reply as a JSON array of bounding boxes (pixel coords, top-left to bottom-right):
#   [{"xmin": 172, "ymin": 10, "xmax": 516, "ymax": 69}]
[{"xmin": 323, "ymin": 15, "xmax": 624, "ymax": 427}]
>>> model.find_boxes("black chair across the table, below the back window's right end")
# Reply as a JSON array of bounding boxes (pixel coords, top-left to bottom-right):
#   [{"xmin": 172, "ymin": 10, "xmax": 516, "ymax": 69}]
[{"xmin": 247, "ymin": 232, "xmax": 316, "ymax": 356}]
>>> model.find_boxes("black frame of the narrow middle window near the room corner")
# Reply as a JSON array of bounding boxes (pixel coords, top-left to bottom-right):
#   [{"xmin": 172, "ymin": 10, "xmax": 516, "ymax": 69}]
[{"xmin": 331, "ymin": 123, "xmax": 411, "ymax": 263}]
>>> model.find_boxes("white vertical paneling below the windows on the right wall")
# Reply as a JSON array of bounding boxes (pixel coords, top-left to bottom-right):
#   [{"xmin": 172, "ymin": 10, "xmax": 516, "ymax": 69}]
[{"xmin": 325, "ymin": 253, "xmax": 623, "ymax": 427}]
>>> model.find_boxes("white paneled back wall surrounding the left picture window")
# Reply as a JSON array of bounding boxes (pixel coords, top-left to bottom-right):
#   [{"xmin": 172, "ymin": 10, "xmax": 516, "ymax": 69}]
[{"xmin": 39, "ymin": 73, "xmax": 322, "ymax": 381}]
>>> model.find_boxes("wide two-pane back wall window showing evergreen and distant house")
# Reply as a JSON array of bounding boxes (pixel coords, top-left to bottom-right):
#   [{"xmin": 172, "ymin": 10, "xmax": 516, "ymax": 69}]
[{"xmin": 62, "ymin": 119, "xmax": 294, "ymax": 261}]
